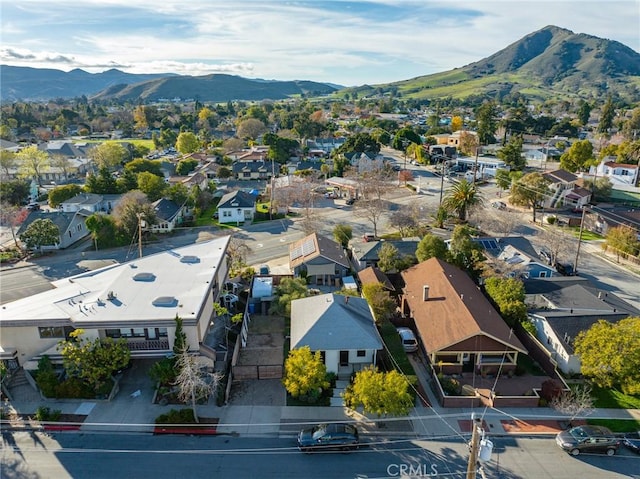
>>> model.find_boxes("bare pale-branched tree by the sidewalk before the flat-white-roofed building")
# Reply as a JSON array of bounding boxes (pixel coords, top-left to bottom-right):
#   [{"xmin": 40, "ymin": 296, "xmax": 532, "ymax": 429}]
[{"xmin": 174, "ymin": 348, "xmax": 224, "ymax": 422}]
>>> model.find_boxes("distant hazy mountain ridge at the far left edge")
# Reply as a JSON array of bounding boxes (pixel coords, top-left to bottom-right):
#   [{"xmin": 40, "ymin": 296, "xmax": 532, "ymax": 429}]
[{"xmin": 0, "ymin": 65, "xmax": 171, "ymax": 102}]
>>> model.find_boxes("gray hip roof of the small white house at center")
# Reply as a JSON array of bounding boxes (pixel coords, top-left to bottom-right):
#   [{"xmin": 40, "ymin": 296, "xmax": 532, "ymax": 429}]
[{"xmin": 291, "ymin": 293, "xmax": 382, "ymax": 351}]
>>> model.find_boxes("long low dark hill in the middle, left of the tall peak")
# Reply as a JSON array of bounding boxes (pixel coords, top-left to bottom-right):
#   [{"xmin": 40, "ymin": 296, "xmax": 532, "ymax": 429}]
[{"xmin": 91, "ymin": 75, "xmax": 337, "ymax": 102}]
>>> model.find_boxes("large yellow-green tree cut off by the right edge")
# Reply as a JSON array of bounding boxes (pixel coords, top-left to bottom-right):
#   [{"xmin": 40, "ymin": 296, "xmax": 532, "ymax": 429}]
[{"xmin": 574, "ymin": 316, "xmax": 640, "ymax": 395}]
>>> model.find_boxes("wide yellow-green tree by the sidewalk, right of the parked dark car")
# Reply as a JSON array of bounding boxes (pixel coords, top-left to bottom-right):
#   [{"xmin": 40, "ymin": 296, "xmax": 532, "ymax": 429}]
[{"xmin": 344, "ymin": 366, "xmax": 413, "ymax": 417}]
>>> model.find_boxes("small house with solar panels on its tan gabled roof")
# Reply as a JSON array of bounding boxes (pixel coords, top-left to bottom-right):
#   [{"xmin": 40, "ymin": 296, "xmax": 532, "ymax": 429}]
[{"xmin": 289, "ymin": 233, "xmax": 351, "ymax": 285}]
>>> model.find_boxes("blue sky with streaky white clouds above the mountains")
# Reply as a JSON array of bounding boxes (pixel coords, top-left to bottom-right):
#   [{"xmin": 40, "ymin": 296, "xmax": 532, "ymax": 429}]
[{"xmin": 0, "ymin": 0, "xmax": 640, "ymax": 86}]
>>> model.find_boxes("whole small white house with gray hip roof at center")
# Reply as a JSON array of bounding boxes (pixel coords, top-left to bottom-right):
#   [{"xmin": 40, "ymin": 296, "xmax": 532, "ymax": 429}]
[{"xmin": 291, "ymin": 293, "xmax": 383, "ymax": 377}]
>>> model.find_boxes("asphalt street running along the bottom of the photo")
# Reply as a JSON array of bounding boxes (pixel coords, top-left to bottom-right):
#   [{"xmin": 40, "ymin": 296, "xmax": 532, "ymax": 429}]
[{"xmin": 2, "ymin": 431, "xmax": 640, "ymax": 479}]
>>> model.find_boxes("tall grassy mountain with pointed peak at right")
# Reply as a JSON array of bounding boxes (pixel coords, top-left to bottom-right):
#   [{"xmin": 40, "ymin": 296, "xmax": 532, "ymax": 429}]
[{"xmin": 339, "ymin": 26, "xmax": 640, "ymax": 103}]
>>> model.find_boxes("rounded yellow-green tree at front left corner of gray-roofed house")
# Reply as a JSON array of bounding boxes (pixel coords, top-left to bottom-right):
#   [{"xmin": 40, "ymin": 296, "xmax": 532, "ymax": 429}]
[{"xmin": 282, "ymin": 346, "xmax": 330, "ymax": 399}]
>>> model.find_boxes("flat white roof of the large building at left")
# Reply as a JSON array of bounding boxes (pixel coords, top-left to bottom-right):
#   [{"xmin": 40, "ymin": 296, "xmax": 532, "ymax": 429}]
[{"xmin": 0, "ymin": 236, "xmax": 230, "ymax": 327}]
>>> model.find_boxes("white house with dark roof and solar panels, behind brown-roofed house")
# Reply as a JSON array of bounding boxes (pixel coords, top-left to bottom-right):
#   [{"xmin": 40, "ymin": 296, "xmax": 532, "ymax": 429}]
[{"xmin": 473, "ymin": 236, "xmax": 558, "ymax": 280}]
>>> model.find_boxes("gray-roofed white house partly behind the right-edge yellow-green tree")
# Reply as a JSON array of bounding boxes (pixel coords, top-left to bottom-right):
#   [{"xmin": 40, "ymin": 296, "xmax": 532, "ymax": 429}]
[{"xmin": 525, "ymin": 276, "xmax": 640, "ymax": 374}]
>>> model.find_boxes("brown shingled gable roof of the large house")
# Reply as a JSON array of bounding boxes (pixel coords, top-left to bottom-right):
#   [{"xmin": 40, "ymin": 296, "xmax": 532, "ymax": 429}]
[{"xmin": 402, "ymin": 258, "xmax": 527, "ymax": 354}]
